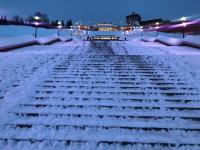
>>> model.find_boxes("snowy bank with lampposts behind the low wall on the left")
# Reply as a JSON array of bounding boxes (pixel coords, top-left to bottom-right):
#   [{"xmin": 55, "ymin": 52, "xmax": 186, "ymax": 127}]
[{"xmin": 0, "ymin": 25, "xmax": 72, "ymax": 51}]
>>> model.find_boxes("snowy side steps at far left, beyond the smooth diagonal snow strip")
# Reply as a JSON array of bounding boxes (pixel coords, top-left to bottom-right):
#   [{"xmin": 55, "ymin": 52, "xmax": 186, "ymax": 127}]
[{"xmin": 0, "ymin": 54, "xmax": 56, "ymax": 101}]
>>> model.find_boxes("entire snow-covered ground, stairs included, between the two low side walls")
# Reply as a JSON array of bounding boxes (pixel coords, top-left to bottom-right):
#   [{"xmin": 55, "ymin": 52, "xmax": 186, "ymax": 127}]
[{"xmin": 0, "ymin": 26, "xmax": 200, "ymax": 150}]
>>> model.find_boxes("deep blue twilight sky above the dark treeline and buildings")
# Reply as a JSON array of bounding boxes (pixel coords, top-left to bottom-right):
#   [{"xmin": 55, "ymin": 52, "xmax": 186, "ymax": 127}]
[{"xmin": 0, "ymin": 0, "xmax": 200, "ymax": 23}]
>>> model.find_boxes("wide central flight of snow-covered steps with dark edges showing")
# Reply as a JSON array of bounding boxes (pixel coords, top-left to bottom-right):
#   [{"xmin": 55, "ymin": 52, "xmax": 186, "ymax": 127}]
[{"xmin": 0, "ymin": 47, "xmax": 200, "ymax": 150}]
